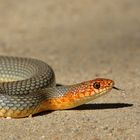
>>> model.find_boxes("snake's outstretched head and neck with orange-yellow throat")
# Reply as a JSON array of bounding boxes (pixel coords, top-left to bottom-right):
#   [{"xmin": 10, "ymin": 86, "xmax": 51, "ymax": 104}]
[{"xmin": 41, "ymin": 78, "xmax": 114, "ymax": 110}]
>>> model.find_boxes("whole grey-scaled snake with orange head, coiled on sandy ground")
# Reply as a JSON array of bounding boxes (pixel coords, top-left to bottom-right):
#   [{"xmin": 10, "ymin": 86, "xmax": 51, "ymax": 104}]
[{"xmin": 0, "ymin": 56, "xmax": 116, "ymax": 118}]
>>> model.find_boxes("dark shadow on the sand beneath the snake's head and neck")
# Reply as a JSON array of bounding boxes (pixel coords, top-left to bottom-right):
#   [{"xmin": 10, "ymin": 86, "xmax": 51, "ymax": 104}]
[{"xmin": 34, "ymin": 103, "xmax": 133, "ymax": 117}]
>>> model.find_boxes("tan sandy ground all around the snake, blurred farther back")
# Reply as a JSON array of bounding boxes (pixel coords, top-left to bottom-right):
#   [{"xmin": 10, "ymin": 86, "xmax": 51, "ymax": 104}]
[{"xmin": 0, "ymin": 0, "xmax": 140, "ymax": 140}]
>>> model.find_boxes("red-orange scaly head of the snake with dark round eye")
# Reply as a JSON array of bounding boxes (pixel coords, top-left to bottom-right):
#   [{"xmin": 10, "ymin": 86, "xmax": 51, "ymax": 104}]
[{"xmin": 70, "ymin": 78, "xmax": 114, "ymax": 100}]
